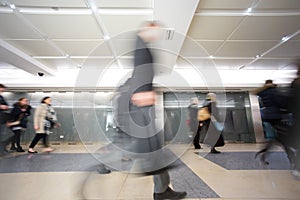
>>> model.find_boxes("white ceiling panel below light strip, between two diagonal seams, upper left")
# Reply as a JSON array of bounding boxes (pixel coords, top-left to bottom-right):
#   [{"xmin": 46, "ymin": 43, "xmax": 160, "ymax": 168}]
[{"xmin": 25, "ymin": 15, "xmax": 102, "ymax": 39}]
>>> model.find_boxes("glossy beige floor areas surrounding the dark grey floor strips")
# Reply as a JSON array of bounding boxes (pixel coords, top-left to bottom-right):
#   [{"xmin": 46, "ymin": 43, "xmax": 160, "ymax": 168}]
[{"xmin": 0, "ymin": 144, "xmax": 300, "ymax": 200}]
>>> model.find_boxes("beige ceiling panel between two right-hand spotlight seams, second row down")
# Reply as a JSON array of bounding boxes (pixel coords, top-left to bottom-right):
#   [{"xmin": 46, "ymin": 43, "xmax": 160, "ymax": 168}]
[{"xmin": 213, "ymin": 41, "xmax": 277, "ymax": 58}]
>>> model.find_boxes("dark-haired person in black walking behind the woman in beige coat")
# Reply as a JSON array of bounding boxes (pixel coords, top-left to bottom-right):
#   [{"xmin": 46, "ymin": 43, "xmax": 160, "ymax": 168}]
[{"xmin": 7, "ymin": 97, "xmax": 31, "ymax": 152}]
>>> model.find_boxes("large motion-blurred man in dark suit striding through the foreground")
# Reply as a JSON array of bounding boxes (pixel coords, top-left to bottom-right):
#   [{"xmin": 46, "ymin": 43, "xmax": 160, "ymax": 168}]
[{"xmin": 125, "ymin": 22, "xmax": 186, "ymax": 199}]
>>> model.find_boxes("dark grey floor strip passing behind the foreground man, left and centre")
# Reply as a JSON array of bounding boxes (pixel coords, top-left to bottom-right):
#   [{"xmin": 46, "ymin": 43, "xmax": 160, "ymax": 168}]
[{"xmin": 0, "ymin": 153, "xmax": 219, "ymax": 198}]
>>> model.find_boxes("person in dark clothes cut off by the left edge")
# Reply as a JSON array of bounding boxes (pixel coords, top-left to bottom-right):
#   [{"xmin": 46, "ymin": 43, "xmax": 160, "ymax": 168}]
[{"xmin": 0, "ymin": 84, "xmax": 9, "ymax": 154}]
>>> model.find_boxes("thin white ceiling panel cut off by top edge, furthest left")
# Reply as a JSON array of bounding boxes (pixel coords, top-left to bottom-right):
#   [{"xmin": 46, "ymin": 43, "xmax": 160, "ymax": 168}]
[{"xmin": 8, "ymin": 0, "xmax": 86, "ymax": 7}]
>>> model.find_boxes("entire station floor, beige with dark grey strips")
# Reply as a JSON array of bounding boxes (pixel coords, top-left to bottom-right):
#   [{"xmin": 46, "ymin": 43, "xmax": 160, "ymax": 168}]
[{"xmin": 0, "ymin": 144, "xmax": 300, "ymax": 200}]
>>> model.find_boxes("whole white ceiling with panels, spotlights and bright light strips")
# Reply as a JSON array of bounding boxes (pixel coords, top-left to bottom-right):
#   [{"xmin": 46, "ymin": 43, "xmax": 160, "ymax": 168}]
[{"xmin": 0, "ymin": 0, "xmax": 300, "ymax": 88}]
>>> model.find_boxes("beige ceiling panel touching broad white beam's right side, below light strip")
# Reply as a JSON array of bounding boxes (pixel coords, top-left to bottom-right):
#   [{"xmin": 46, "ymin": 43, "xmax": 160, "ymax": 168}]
[{"xmin": 188, "ymin": 16, "xmax": 243, "ymax": 40}]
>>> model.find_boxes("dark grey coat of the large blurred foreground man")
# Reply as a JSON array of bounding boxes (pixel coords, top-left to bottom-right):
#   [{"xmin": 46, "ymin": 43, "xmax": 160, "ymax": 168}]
[{"xmin": 129, "ymin": 36, "xmax": 162, "ymax": 156}]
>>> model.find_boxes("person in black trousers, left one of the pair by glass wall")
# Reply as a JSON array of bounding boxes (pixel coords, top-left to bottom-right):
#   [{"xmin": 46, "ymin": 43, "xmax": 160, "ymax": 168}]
[{"xmin": 188, "ymin": 97, "xmax": 201, "ymax": 149}]
